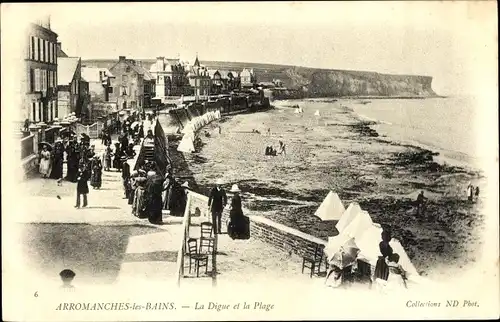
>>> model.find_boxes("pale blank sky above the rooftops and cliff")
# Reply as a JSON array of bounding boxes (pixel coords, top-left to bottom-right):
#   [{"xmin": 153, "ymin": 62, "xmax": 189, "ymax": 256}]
[{"xmin": 2, "ymin": 1, "xmax": 497, "ymax": 95}]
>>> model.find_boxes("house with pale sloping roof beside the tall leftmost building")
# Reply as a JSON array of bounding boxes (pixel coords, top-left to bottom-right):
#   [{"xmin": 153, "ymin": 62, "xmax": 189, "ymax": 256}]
[{"xmin": 57, "ymin": 57, "xmax": 90, "ymax": 120}]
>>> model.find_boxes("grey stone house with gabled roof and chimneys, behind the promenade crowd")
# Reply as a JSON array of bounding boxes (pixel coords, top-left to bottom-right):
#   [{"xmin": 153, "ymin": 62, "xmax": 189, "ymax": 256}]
[{"xmin": 109, "ymin": 56, "xmax": 144, "ymax": 112}]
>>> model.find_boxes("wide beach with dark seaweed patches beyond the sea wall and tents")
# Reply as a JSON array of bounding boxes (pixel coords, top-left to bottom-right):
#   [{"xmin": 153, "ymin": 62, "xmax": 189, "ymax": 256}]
[{"xmin": 162, "ymin": 99, "xmax": 483, "ymax": 277}]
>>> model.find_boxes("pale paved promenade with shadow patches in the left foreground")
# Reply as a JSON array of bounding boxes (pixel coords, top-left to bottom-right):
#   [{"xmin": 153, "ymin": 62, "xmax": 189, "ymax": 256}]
[{"xmin": 14, "ymin": 135, "xmax": 183, "ymax": 282}]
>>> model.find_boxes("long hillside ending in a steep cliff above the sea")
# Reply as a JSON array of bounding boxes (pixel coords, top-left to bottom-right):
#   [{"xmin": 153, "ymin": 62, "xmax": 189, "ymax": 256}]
[{"xmin": 82, "ymin": 59, "xmax": 436, "ymax": 97}]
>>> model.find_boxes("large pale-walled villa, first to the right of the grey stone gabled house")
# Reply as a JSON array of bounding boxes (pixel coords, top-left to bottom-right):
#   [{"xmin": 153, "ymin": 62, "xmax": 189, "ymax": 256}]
[{"xmin": 149, "ymin": 57, "xmax": 188, "ymax": 100}]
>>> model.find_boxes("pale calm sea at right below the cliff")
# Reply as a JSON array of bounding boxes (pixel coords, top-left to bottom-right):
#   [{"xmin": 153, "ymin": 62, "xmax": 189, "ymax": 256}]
[{"xmin": 345, "ymin": 96, "xmax": 484, "ymax": 168}]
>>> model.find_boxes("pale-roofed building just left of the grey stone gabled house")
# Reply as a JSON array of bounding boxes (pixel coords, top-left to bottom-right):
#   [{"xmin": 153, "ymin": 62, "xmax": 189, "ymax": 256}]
[{"xmin": 82, "ymin": 67, "xmax": 118, "ymax": 121}]
